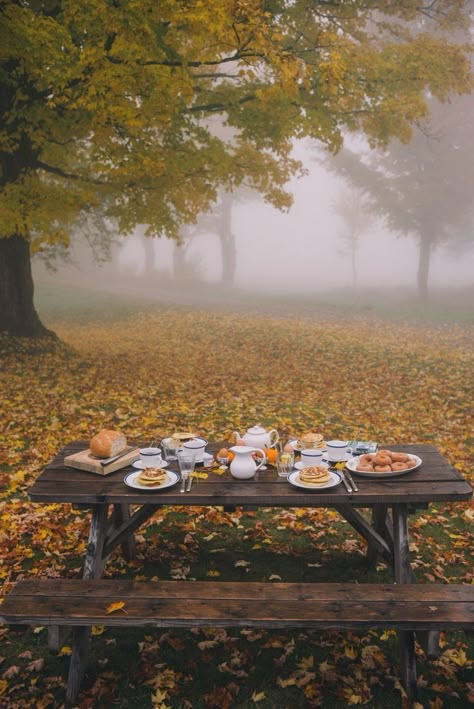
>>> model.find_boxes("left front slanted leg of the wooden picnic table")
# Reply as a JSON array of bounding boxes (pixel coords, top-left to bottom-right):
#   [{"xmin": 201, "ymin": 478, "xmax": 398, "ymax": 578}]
[{"xmin": 66, "ymin": 505, "xmax": 108, "ymax": 704}]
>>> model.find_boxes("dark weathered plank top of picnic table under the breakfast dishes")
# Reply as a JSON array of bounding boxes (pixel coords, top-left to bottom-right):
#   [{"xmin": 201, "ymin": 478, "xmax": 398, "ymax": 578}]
[{"xmin": 29, "ymin": 441, "xmax": 473, "ymax": 507}]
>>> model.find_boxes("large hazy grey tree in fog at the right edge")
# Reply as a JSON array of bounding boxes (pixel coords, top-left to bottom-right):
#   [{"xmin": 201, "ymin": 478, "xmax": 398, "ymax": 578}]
[{"xmin": 324, "ymin": 95, "xmax": 474, "ymax": 299}]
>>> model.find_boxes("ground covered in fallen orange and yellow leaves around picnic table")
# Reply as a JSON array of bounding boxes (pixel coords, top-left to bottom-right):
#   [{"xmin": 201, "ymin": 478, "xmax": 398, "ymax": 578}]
[{"xmin": 0, "ymin": 309, "xmax": 474, "ymax": 709}]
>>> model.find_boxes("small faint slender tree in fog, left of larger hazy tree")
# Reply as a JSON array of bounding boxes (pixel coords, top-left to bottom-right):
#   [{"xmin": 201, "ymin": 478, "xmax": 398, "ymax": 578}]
[{"xmin": 333, "ymin": 187, "xmax": 373, "ymax": 289}]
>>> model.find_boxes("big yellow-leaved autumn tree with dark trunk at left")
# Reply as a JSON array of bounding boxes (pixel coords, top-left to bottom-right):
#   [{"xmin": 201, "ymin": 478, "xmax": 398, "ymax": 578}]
[{"xmin": 0, "ymin": 0, "xmax": 471, "ymax": 336}]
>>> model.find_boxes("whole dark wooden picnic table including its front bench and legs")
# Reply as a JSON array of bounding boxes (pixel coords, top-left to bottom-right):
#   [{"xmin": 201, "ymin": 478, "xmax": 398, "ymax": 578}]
[{"xmin": 0, "ymin": 443, "xmax": 474, "ymax": 702}]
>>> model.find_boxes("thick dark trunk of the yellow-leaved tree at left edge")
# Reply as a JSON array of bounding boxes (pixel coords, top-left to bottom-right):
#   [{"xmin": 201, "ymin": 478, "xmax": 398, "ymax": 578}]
[{"xmin": 0, "ymin": 236, "xmax": 56, "ymax": 337}]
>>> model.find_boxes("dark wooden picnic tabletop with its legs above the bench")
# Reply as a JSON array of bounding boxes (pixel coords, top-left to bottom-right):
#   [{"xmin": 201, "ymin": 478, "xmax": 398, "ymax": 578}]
[{"xmin": 29, "ymin": 441, "xmax": 472, "ymax": 583}]
